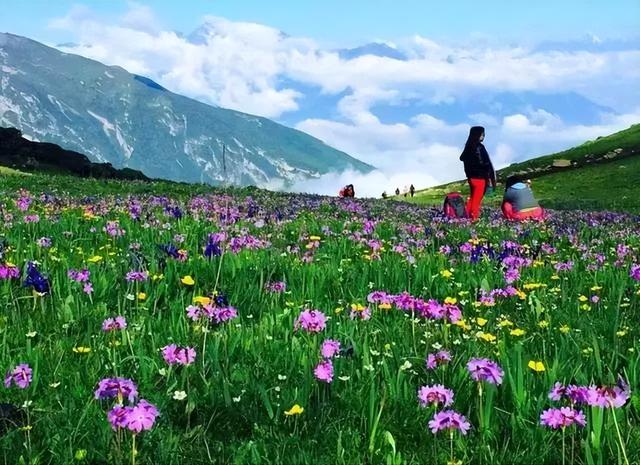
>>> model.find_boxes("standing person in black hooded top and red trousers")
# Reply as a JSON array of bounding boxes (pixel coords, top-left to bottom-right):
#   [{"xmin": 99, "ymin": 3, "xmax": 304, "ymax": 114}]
[{"xmin": 460, "ymin": 126, "xmax": 496, "ymax": 221}]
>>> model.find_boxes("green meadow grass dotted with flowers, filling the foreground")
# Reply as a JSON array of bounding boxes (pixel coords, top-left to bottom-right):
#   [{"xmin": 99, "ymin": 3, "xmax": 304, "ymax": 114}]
[{"xmin": 0, "ymin": 170, "xmax": 640, "ymax": 465}]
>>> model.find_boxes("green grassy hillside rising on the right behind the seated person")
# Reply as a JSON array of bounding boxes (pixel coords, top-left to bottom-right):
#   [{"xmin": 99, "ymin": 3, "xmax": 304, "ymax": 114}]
[{"xmin": 402, "ymin": 124, "xmax": 640, "ymax": 212}]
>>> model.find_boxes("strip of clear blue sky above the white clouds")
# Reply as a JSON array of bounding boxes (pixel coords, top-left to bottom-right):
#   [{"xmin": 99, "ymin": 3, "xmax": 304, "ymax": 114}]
[{"xmin": 0, "ymin": 0, "xmax": 640, "ymax": 45}]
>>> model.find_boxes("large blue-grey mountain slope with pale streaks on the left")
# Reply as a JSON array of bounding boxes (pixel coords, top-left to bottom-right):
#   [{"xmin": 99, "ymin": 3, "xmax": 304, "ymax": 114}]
[{"xmin": 0, "ymin": 33, "xmax": 373, "ymax": 186}]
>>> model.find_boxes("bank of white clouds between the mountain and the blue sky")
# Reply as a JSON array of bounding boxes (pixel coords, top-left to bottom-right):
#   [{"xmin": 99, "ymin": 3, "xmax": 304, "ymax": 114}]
[{"xmin": 45, "ymin": 2, "xmax": 640, "ymax": 192}]
